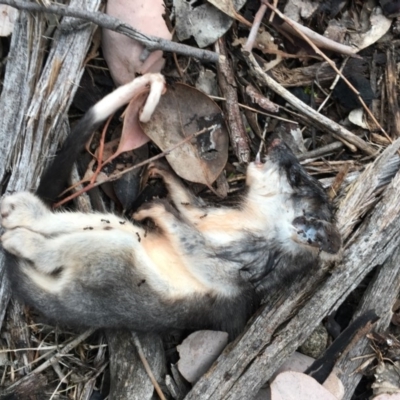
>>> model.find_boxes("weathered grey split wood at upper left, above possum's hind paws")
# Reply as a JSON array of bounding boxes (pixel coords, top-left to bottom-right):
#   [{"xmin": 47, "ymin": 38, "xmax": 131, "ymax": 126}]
[{"xmin": 0, "ymin": 0, "xmax": 100, "ymax": 325}]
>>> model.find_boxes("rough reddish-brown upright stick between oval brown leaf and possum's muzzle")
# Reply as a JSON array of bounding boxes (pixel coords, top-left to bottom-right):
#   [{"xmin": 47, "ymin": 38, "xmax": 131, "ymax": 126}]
[{"xmin": 216, "ymin": 38, "xmax": 250, "ymax": 163}]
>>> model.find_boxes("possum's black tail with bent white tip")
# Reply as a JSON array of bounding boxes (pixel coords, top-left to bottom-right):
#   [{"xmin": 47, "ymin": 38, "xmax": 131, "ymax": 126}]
[{"xmin": 36, "ymin": 74, "xmax": 165, "ymax": 205}]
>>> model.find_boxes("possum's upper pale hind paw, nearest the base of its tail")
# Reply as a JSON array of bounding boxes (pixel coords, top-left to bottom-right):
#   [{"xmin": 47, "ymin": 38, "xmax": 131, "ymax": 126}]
[{"xmin": 0, "ymin": 192, "xmax": 50, "ymax": 229}]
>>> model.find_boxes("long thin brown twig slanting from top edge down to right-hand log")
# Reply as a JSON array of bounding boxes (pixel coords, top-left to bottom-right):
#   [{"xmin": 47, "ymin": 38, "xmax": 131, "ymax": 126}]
[{"xmin": 261, "ymin": 0, "xmax": 393, "ymax": 143}]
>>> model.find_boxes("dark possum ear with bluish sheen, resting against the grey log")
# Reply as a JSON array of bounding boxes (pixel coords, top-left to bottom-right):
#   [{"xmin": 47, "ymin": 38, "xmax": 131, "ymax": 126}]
[{"xmin": 292, "ymin": 216, "xmax": 342, "ymax": 254}]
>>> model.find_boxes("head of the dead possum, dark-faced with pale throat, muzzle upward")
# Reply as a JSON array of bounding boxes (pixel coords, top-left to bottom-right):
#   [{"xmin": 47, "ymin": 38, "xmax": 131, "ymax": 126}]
[{"xmin": 247, "ymin": 139, "xmax": 341, "ymax": 254}]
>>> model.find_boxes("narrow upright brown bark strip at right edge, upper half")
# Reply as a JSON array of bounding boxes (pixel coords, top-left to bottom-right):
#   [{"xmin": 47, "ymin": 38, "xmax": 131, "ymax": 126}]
[{"xmin": 385, "ymin": 47, "xmax": 400, "ymax": 138}]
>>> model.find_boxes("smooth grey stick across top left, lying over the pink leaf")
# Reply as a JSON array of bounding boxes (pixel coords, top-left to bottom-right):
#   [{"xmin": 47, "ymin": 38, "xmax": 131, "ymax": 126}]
[{"xmin": 0, "ymin": 0, "xmax": 222, "ymax": 63}]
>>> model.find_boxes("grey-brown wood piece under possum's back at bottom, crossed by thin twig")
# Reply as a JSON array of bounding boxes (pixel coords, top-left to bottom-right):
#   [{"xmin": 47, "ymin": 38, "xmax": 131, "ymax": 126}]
[{"xmin": 107, "ymin": 331, "xmax": 165, "ymax": 400}]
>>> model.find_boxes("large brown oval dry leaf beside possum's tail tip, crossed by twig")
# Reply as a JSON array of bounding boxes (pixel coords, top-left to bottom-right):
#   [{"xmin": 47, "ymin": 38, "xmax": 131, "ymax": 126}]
[{"xmin": 142, "ymin": 84, "xmax": 229, "ymax": 186}]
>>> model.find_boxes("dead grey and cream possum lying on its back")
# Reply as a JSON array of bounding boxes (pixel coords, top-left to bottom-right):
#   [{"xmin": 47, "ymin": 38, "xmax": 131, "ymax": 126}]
[{"xmin": 1, "ymin": 75, "xmax": 341, "ymax": 338}]
